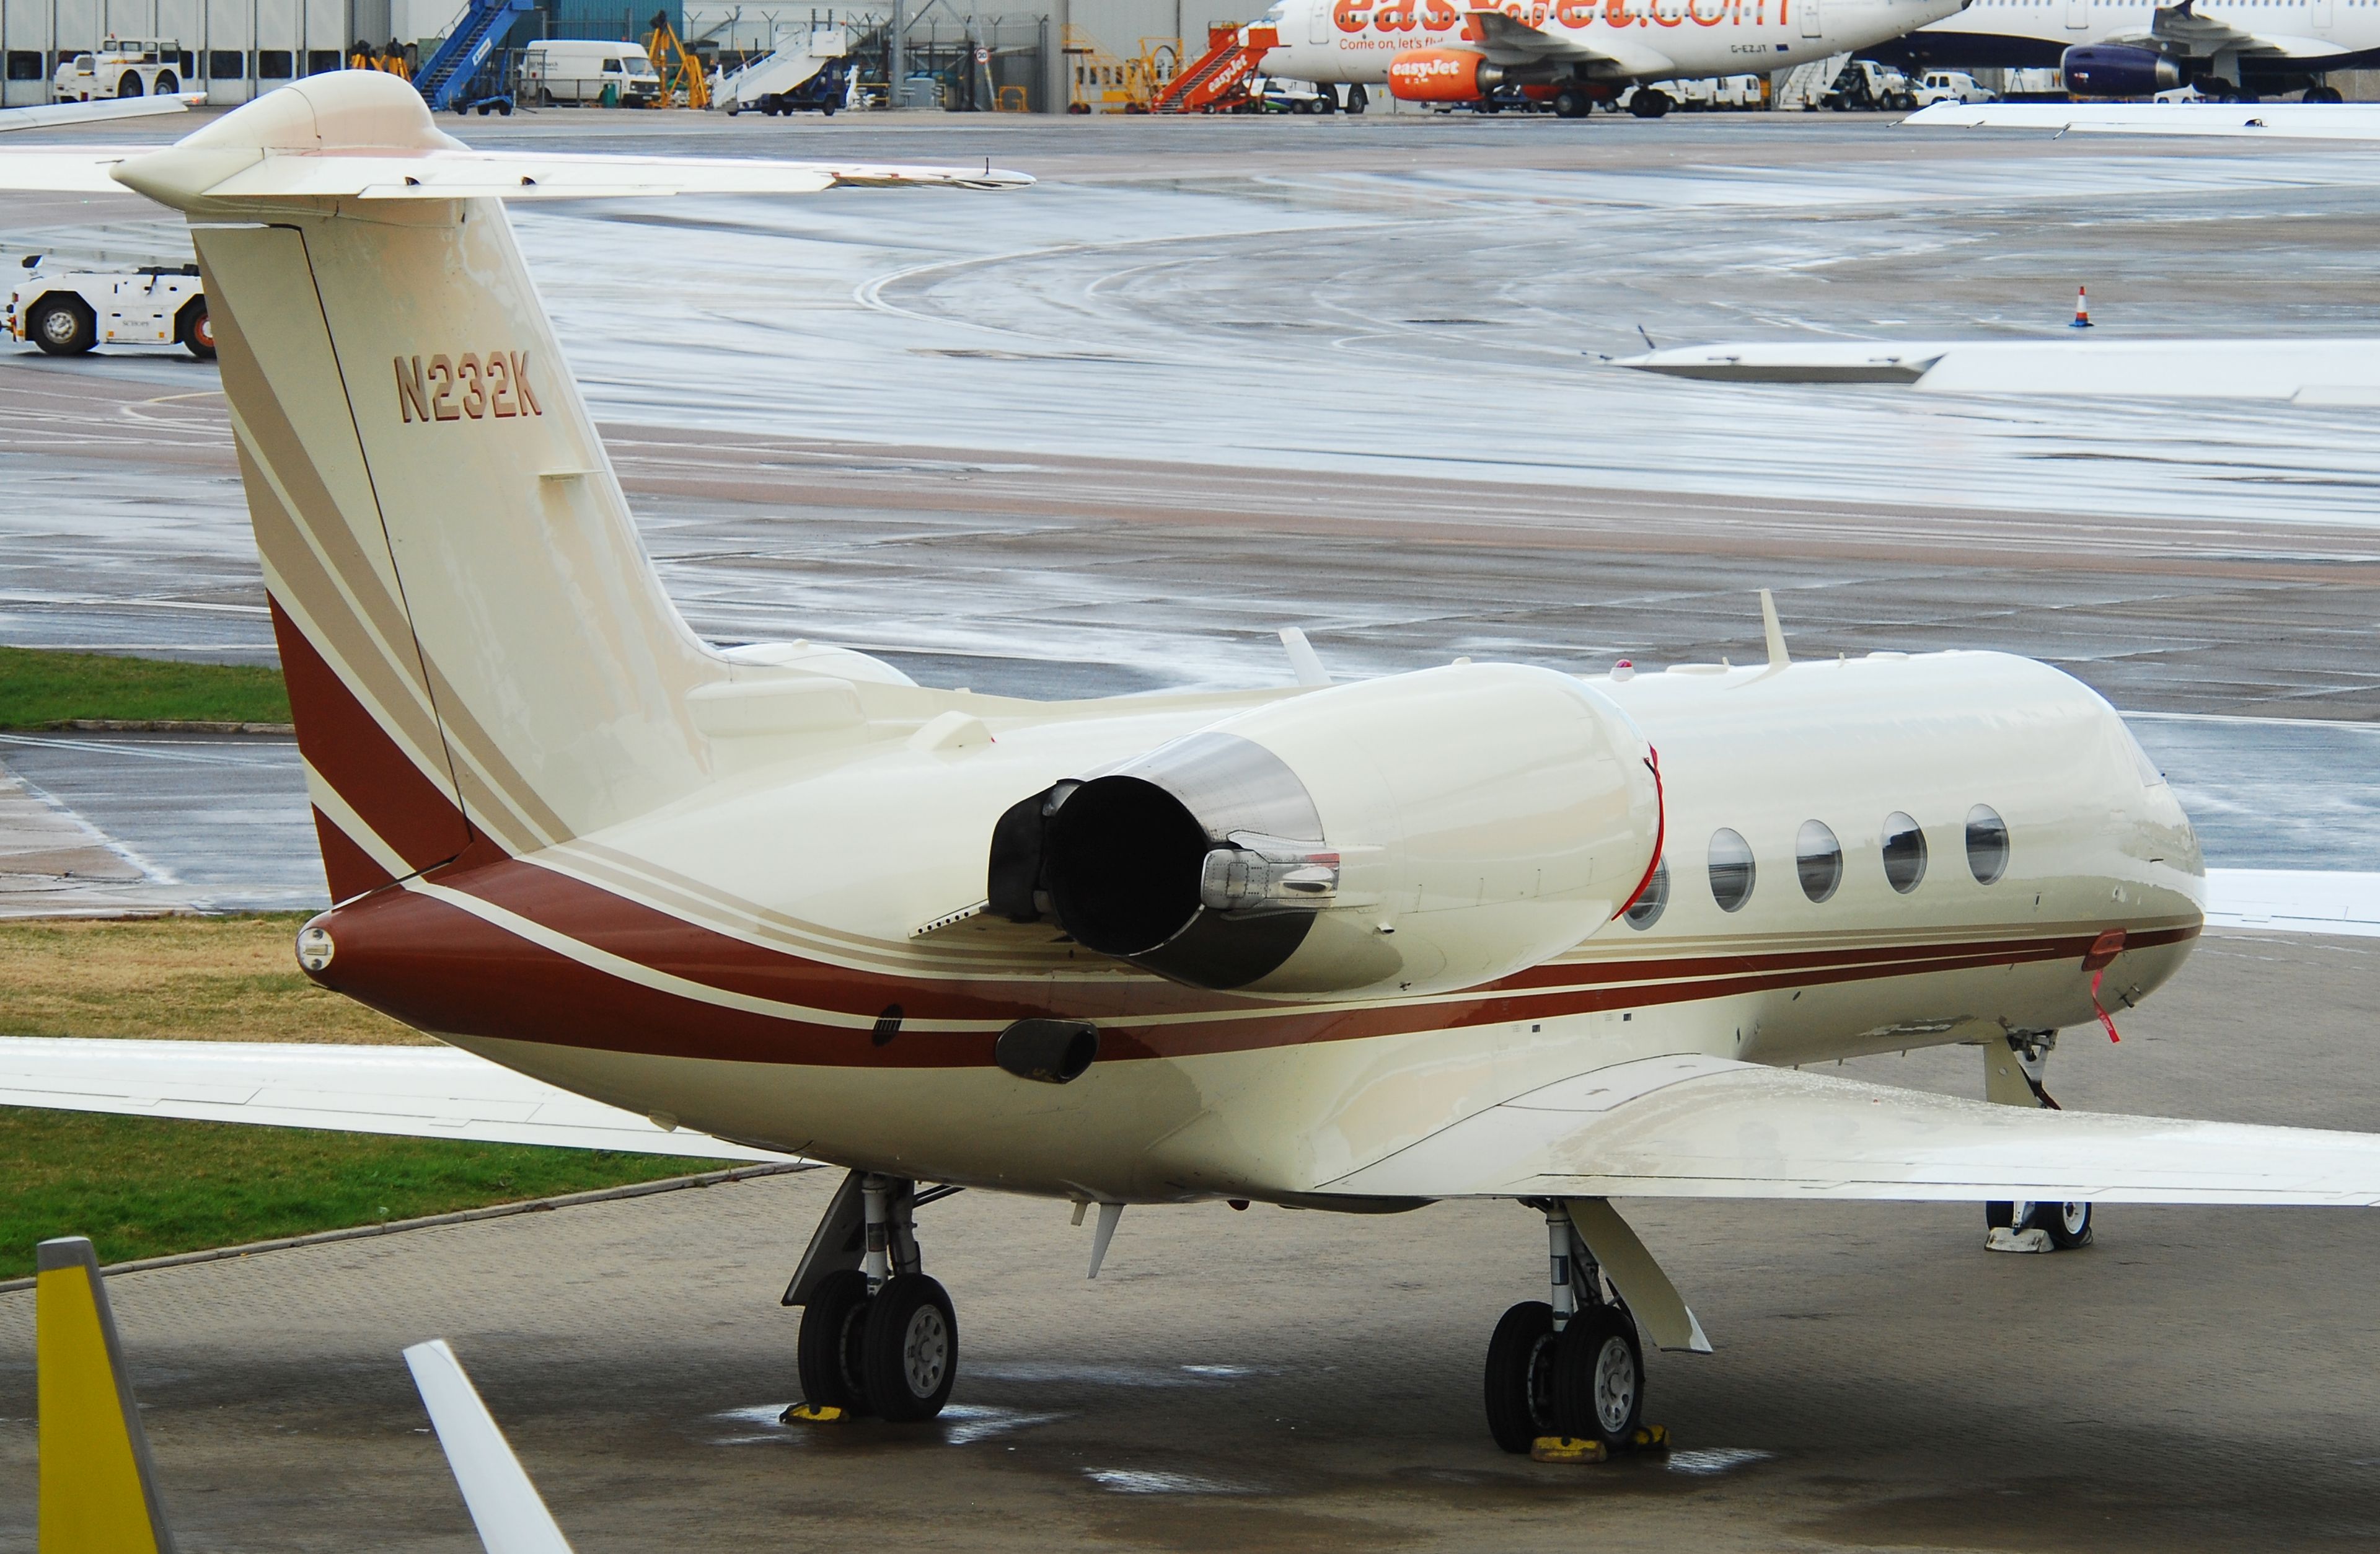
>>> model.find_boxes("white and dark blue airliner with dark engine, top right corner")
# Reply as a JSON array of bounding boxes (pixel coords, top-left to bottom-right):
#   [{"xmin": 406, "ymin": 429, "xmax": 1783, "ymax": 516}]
[{"xmin": 1878, "ymin": 0, "xmax": 2380, "ymax": 102}]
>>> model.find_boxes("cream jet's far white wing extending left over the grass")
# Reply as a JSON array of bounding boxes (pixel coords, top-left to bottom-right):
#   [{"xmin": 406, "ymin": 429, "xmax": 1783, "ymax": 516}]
[{"xmin": 0, "ymin": 1035, "xmax": 785, "ymax": 1162}]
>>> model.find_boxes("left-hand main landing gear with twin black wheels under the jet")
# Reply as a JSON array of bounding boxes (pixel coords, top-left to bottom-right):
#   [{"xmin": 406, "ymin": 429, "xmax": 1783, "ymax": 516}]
[{"xmin": 785, "ymin": 1171, "xmax": 959, "ymax": 1423}]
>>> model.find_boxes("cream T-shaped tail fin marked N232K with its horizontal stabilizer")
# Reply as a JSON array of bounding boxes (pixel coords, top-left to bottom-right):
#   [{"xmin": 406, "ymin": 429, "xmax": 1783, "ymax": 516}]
[{"xmin": 56, "ymin": 71, "xmax": 1019, "ymax": 899}]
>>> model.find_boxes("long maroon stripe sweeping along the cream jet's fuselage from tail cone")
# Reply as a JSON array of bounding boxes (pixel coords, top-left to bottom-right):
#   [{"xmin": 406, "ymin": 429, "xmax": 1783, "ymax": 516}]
[{"xmin": 307, "ymin": 862, "xmax": 2197, "ymax": 1066}]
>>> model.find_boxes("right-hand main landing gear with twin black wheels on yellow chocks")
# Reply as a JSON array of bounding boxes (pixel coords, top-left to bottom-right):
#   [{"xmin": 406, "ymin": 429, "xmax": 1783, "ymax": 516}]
[{"xmin": 1488, "ymin": 1202, "xmax": 1666, "ymax": 1461}]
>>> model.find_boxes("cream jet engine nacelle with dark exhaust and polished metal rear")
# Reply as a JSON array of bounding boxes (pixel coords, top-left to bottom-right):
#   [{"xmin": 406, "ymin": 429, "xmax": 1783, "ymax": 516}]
[{"xmin": 990, "ymin": 664, "xmax": 1661, "ymax": 997}]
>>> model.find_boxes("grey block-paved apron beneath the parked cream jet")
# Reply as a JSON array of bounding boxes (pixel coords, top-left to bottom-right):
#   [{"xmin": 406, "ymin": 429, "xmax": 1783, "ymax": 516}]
[{"xmin": 0, "ymin": 935, "xmax": 2380, "ymax": 1554}]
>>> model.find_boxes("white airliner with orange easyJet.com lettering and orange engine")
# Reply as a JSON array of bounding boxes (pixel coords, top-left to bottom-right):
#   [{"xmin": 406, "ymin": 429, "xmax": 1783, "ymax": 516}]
[{"xmin": 1264, "ymin": 0, "xmax": 1968, "ymax": 119}]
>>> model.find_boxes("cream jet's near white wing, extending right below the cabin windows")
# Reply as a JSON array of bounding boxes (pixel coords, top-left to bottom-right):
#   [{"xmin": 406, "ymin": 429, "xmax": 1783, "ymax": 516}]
[{"xmin": 1321, "ymin": 1054, "xmax": 2380, "ymax": 1206}]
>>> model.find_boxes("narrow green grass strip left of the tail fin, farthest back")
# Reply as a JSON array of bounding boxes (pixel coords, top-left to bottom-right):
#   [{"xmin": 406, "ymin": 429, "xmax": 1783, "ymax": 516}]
[{"xmin": 0, "ymin": 647, "xmax": 290, "ymax": 728}]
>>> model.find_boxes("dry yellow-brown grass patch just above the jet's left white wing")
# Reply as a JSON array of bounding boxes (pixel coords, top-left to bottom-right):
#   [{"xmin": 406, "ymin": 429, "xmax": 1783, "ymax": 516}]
[{"xmin": 0, "ymin": 911, "xmax": 428, "ymax": 1044}]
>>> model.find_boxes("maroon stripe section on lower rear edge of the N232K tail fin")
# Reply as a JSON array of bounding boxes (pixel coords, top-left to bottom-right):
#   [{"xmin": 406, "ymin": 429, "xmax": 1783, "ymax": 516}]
[{"xmin": 267, "ymin": 595, "xmax": 471, "ymax": 899}]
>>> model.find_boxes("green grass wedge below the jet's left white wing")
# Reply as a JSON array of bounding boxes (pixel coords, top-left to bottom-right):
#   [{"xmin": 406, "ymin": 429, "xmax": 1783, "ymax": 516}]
[{"xmin": 0, "ymin": 1106, "xmax": 719, "ymax": 1278}]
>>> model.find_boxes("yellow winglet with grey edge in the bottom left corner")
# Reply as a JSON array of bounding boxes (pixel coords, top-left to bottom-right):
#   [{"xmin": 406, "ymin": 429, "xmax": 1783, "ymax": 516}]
[{"xmin": 33, "ymin": 1235, "xmax": 174, "ymax": 1554}]
